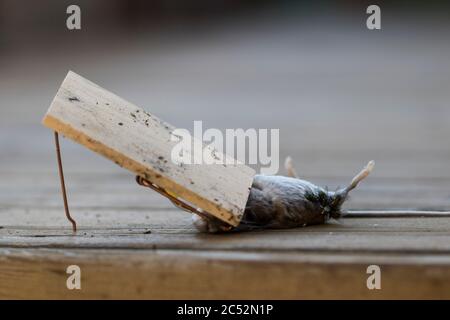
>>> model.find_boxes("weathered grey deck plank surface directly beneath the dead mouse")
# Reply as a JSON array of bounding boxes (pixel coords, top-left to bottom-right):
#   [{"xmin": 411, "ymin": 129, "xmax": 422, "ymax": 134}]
[{"xmin": 0, "ymin": 216, "xmax": 450, "ymax": 255}]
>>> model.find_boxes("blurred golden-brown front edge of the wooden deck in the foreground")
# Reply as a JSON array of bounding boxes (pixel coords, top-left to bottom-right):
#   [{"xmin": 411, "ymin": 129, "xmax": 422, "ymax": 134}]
[{"xmin": 0, "ymin": 248, "xmax": 450, "ymax": 299}]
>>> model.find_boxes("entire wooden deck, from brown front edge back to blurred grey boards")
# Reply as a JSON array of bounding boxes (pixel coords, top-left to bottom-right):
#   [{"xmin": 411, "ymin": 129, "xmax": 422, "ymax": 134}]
[{"xmin": 0, "ymin": 10, "xmax": 450, "ymax": 299}]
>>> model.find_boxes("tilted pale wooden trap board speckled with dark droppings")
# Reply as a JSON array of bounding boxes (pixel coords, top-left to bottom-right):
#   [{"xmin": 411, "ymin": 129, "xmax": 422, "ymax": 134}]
[{"xmin": 43, "ymin": 71, "xmax": 255, "ymax": 226}]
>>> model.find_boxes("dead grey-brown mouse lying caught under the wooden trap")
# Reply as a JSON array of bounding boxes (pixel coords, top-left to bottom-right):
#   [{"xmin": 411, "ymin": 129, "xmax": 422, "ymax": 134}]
[{"xmin": 193, "ymin": 157, "xmax": 375, "ymax": 233}]
